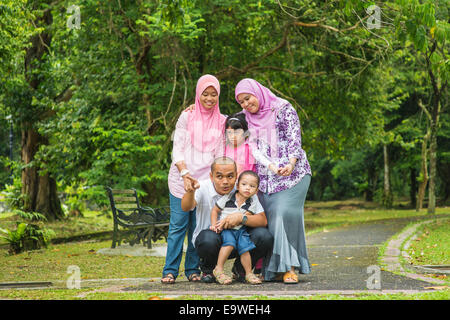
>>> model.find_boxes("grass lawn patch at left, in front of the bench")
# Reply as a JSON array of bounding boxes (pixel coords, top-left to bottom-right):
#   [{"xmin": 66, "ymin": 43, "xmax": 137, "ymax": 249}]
[{"xmin": 0, "ymin": 240, "xmax": 164, "ymax": 282}]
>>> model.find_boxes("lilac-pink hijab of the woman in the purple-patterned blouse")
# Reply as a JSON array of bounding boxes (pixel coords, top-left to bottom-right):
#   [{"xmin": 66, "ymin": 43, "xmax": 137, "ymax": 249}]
[{"xmin": 234, "ymin": 78, "xmax": 288, "ymax": 156}]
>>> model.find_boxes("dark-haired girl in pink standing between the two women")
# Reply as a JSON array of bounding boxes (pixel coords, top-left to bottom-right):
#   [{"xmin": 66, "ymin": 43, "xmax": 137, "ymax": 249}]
[{"xmin": 224, "ymin": 112, "xmax": 255, "ymax": 176}]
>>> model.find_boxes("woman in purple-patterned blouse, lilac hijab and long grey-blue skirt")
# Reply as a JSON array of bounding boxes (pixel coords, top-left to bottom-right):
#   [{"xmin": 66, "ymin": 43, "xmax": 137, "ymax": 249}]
[{"xmin": 235, "ymin": 79, "xmax": 311, "ymax": 283}]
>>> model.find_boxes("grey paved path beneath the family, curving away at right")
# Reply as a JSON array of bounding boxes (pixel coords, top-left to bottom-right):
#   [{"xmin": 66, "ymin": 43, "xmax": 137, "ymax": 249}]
[{"xmin": 109, "ymin": 215, "xmax": 446, "ymax": 296}]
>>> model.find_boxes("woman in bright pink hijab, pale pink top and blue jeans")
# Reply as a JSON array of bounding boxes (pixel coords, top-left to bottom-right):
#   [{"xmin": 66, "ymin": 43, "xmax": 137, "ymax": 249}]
[{"xmin": 161, "ymin": 74, "xmax": 225, "ymax": 283}]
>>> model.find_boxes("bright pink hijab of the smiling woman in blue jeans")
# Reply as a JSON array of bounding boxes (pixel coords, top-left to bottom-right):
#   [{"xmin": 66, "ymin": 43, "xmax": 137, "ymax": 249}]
[{"xmin": 188, "ymin": 74, "xmax": 226, "ymax": 152}]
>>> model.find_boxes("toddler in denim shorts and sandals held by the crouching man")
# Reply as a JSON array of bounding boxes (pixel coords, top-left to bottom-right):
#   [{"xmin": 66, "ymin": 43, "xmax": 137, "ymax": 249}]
[{"xmin": 210, "ymin": 170, "xmax": 264, "ymax": 284}]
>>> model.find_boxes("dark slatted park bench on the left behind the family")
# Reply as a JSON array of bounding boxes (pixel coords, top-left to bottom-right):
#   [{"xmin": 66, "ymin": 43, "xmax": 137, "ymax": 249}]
[{"xmin": 106, "ymin": 187, "xmax": 170, "ymax": 249}]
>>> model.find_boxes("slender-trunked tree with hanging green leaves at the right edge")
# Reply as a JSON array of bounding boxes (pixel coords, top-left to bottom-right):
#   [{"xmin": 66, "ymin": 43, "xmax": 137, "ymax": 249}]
[{"xmin": 395, "ymin": 0, "xmax": 450, "ymax": 213}]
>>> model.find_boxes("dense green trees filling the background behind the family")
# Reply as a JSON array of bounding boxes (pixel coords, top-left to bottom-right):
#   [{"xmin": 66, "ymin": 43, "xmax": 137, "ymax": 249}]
[{"xmin": 0, "ymin": 0, "xmax": 450, "ymax": 218}]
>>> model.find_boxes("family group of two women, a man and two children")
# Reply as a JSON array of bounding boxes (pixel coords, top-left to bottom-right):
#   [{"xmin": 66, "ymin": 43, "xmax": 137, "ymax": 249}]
[{"xmin": 161, "ymin": 74, "xmax": 311, "ymax": 284}]
